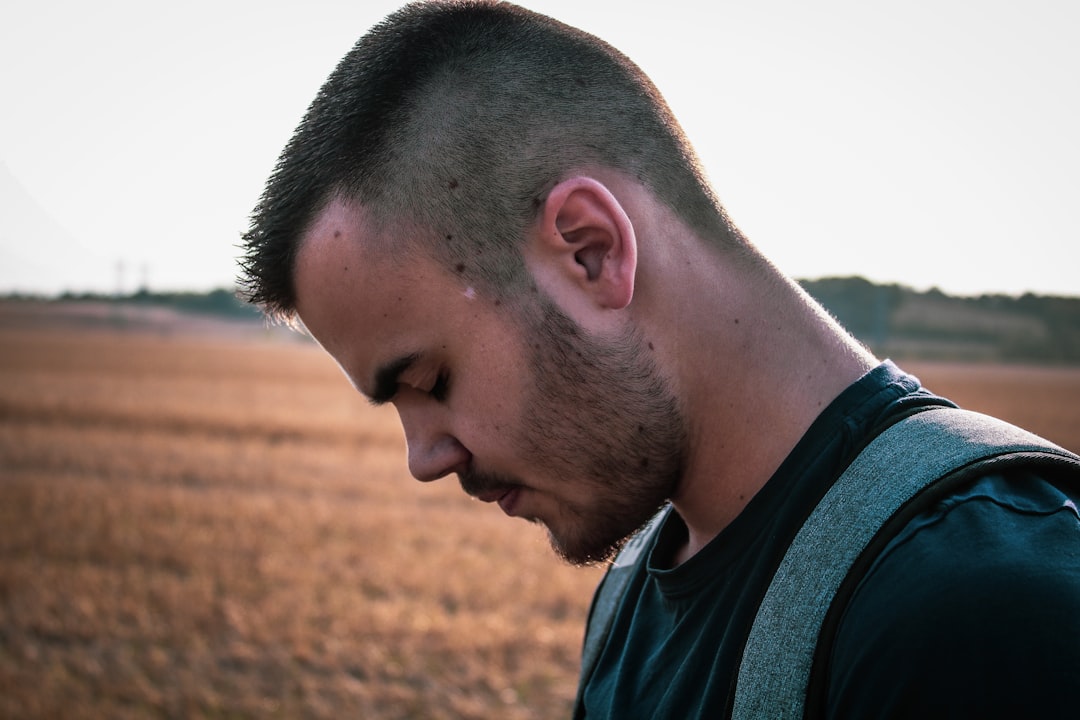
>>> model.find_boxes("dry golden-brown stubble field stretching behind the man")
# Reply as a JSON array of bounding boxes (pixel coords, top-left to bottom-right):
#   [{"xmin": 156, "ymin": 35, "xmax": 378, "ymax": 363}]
[{"xmin": 0, "ymin": 304, "xmax": 1080, "ymax": 719}]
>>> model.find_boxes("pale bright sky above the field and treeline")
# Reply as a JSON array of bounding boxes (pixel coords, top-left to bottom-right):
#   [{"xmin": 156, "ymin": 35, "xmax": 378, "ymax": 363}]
[{"xmin": 0, "ymin": 0, "xmax": 1080, "ymax": 296}]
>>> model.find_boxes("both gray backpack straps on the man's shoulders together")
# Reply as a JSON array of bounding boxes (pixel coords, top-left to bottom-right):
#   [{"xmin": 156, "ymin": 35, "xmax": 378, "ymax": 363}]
[{"xmin": 575, "ymin": 407, "xmax": 1080, "ymax": 720}]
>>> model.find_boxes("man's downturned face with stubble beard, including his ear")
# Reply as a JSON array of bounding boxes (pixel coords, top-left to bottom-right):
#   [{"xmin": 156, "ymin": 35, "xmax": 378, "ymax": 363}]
[{"xmin": 296, "ymin": 195, "xmax": 688, "ymax": 562}]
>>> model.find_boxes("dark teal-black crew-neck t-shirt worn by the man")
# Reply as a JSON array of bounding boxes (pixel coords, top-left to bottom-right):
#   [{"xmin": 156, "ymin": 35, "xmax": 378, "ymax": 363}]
[{"xmin": 583, "ymin": 362, "xmax": 1080, "ymax": 719}]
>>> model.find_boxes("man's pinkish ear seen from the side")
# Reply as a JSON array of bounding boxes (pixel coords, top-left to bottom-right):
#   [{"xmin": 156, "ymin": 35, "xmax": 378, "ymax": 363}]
[{"xmin": 530, "ymin": 177, "xmax": 637, "ymax": 310}]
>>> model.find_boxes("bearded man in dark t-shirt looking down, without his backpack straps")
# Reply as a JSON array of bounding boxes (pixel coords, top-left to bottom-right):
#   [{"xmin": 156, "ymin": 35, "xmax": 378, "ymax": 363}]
[{"xmin": 242, "ymin": 2, "xmax": 1080, "ymax": 718}]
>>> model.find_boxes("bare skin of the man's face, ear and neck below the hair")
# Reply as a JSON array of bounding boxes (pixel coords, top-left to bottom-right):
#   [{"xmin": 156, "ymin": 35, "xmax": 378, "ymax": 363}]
[{"xmin": 295, "ymin": 168, "xmax": 876, "ymax": 563}]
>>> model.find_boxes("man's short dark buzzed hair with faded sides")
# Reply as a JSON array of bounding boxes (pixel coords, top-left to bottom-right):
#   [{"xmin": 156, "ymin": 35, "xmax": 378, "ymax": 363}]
[{"xmin": 240, "ymin": 1, "xmax": 747, "ymax": 322}]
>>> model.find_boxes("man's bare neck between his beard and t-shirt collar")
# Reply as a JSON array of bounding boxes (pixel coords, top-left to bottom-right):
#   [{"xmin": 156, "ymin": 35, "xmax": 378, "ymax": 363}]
[{"xmin": 639, "ymin": 247, "xmax": 877, "ymax": 562}]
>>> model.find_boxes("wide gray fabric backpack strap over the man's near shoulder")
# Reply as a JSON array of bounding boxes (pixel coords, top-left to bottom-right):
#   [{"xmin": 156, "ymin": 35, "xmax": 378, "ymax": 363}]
[{"xmin": 731, "ymin": 408, "xmax": 1077, "ymax": 720}]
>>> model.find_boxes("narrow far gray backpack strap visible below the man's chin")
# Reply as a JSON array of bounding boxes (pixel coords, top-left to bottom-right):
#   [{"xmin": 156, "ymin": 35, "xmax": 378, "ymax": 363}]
[{"xmin": 573, "ymin": 505, "xmax": 671, "ymax": 718}]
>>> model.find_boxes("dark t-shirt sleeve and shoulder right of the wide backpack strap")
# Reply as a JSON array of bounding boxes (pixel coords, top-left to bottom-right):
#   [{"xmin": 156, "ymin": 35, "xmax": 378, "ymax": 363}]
[{"xmin": 826, "ymin": 474, "xmax": 1080, "ymax": 719}]
